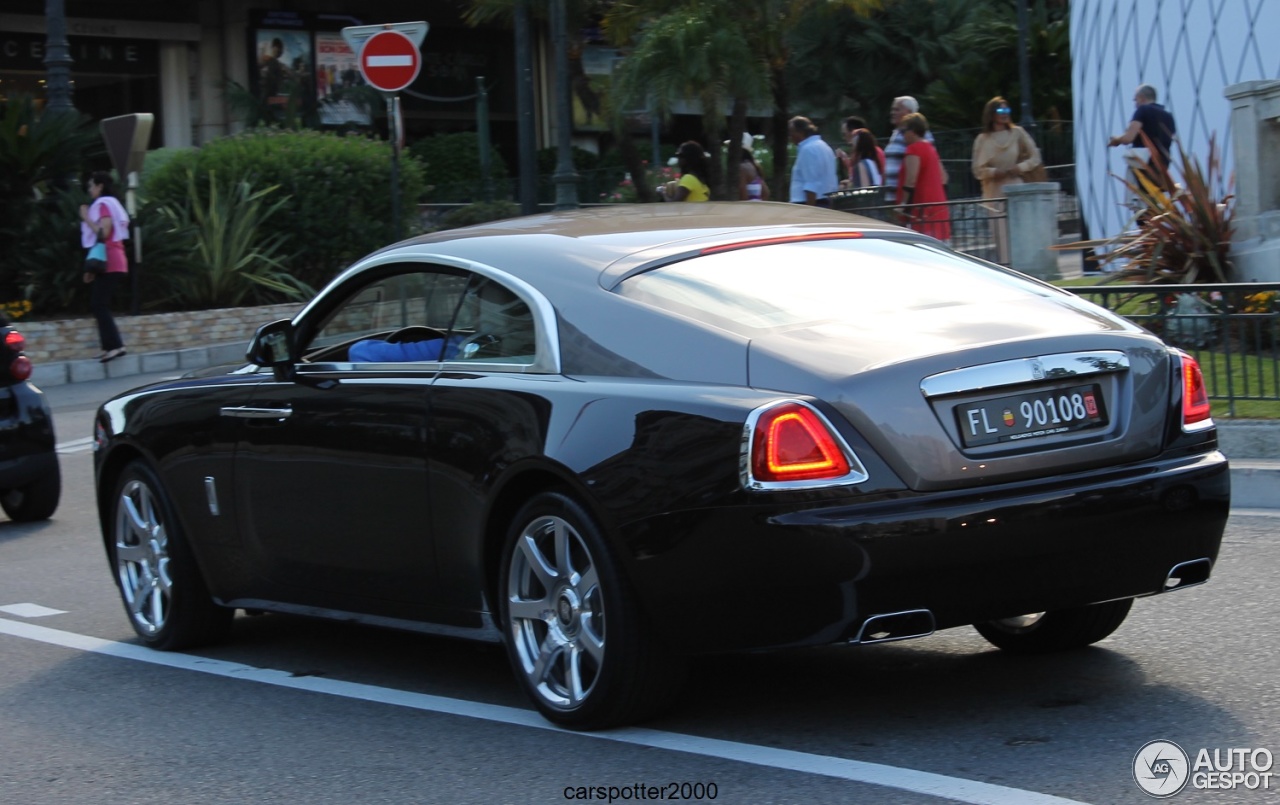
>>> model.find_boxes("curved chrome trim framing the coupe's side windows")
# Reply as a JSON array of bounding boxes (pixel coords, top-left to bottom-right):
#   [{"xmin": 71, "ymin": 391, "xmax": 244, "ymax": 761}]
[{"xmin": 293, "ymin": 246, "xmax": 561, "ymax": 375}]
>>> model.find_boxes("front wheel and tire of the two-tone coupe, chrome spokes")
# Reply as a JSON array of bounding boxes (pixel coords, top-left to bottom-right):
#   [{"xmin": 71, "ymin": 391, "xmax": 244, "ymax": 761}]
[{"xmin": 109, "ymin": 461, "xmax": 236, "ymax": 651}]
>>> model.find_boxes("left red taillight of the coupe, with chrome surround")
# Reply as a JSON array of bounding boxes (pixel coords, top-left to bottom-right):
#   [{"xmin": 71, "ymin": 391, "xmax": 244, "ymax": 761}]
[{"xmin": 744, "ymin": 399, "xmax": 867, "ymax": 489}]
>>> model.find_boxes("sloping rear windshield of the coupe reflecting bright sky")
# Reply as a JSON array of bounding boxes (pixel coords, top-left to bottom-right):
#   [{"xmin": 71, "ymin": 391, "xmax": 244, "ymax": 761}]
[{"xmin": 618, "ymin": 238, "xmax": 1053, "ymax": 335}]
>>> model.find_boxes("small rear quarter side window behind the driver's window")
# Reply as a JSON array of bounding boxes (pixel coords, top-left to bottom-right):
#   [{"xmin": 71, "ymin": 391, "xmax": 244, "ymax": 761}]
[{"xmin": 448, "ymin": 275, "xmax": 536, "ymax": 363}]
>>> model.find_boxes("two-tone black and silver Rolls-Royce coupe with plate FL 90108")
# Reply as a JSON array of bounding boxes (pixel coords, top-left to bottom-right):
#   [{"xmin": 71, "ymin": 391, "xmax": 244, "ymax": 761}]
[{"xmin": 95, "ymin": 202, "xmax": 1230, "ymax": 728}]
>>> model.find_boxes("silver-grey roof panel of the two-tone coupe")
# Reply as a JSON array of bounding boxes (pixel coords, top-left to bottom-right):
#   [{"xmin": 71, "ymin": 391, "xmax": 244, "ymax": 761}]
[{"xmin": 376, "ymin": 201, "xmax": 928, "ymax": 288}]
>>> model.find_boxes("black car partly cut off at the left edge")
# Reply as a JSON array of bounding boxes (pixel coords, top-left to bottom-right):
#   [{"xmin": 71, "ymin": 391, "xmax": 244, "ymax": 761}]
[{"xmin": 0, "ymin": 315, "xmax": 63, "ymax": 522}]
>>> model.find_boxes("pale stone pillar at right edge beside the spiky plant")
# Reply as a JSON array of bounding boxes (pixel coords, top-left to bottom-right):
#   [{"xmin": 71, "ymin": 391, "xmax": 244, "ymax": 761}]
[{"xmin": 1222, "ymin": 81, "xmax": 1280, "ymax": 283}]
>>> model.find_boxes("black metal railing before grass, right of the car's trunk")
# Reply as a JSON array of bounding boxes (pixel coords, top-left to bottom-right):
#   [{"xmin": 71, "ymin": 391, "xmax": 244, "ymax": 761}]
[{"xmin": 1066, "ymin": 283, "xmax": 1280, "ymax": 417}]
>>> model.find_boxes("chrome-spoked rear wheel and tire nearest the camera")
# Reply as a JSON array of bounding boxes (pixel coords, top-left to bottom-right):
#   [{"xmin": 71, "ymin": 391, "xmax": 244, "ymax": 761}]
[{"xmin": 498, "ymin": 493, "xmax": 684, "ymax": 729}]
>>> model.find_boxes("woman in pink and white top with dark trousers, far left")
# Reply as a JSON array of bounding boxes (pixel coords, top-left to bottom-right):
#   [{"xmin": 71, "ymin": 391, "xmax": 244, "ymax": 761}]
[{"xmin": 81, "ymin": 170, "xmax": 129, "ymax": 363}]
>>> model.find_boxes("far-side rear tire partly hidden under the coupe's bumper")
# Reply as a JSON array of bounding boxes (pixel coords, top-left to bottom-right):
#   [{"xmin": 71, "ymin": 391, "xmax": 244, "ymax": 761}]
[{"xmin": 974, "ymin": 598, "xmax": 1133, "ymax": 654}]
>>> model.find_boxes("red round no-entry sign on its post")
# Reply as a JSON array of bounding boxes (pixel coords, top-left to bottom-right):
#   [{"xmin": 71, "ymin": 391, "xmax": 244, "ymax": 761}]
[{"xmin": 342, "ymin": 22, "xmax": 428, "ymax": 241}]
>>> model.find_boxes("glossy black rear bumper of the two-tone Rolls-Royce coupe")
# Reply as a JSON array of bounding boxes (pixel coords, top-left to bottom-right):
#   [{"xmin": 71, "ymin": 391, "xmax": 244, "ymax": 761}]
[{"xmin": 625, "ymin": 452, "xmax": 1230, "ymax": 653}]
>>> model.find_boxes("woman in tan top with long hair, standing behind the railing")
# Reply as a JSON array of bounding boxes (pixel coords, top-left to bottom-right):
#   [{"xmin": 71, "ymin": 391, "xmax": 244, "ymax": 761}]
[{"xmin": 973, "ymin": 96, "xmax": 1044, "ymax": 265}]
